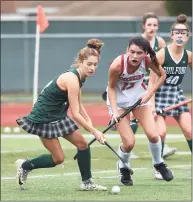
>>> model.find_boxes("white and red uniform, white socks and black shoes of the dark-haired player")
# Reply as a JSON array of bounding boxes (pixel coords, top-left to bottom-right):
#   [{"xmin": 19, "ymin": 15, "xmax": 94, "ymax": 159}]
[{"xmin": 106, "ymin": 54, "xmax": 173, "ymax": 186}]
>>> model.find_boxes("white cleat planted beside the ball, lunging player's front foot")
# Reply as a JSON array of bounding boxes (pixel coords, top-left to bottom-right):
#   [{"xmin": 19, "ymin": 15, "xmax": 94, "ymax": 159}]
[{"xmin": 80, "ymin": 179, "xmax": 107, "ymax": 191}]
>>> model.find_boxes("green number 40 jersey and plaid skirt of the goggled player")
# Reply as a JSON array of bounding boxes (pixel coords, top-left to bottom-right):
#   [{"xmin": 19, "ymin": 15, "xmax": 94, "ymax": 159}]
[{"xmin": 155, "ymin": 46, "xmax": 189, "ymax": 116}]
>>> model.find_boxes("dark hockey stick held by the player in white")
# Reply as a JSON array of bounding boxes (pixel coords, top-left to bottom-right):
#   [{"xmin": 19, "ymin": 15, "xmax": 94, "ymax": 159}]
[{"xmin": 74, "ymin": 99, "xmax": 141, "ymax": 160}]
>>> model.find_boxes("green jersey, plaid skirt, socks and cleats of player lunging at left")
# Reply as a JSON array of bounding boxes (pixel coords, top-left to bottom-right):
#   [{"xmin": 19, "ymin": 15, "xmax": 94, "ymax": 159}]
[{"xmin": 15, "ymin": 68, "xmax": 107, "ymax": 191}]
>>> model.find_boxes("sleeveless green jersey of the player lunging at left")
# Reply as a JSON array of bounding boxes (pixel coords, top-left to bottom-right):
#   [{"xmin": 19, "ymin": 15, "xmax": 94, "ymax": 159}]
[{"xmin": 27, "ymin": 68, "xmax": 85, "ymax": 123}]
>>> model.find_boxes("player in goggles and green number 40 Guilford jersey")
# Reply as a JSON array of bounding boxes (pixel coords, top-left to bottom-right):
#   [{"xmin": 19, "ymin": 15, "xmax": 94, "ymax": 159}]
[{"xmin": 149, "ymin": 14, "xmax": 192, "ymax": 155}]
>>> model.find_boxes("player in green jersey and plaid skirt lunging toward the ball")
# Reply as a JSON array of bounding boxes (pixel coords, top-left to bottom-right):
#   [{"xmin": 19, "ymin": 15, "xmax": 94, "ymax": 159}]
[{"xmin": 15, "ymin": 39, "xmax": 107, "ymax": 191}]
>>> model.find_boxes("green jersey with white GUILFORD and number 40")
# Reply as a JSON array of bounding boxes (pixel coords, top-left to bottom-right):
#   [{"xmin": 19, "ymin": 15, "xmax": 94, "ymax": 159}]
[{"xmin": 162, "ymin": 47, "xmax": 188, "ymax": 86}]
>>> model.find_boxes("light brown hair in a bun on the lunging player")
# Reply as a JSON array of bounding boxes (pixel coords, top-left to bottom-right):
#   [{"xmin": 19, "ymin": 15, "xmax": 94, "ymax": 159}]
[{"xmin": 72, "ymin": 39, "xmax": 104, "ymax": 66}]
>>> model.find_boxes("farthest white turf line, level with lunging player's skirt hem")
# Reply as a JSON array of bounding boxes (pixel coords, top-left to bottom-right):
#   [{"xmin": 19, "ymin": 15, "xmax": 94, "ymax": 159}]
[{"xmin": 1, "ymin": 133, "xmax": 184, "ymax": 139}]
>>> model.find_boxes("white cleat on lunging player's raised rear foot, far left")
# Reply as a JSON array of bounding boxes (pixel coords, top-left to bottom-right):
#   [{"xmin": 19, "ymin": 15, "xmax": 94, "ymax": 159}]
[{"xmin": 15, "ymin": 159, "xmax": 30, "ymax": 190}]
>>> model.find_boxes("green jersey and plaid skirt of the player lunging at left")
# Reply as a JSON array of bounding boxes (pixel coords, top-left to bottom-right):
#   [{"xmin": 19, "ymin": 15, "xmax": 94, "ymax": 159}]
[{"xmin": 16, "ymin": 69, "xmax": 84, "ymax": 138}]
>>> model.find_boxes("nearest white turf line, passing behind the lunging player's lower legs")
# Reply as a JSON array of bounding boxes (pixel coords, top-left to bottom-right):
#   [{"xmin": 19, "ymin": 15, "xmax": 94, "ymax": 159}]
[{"xmin": 1, "ymin": 165, "xmax": 191, "ymax": 180}]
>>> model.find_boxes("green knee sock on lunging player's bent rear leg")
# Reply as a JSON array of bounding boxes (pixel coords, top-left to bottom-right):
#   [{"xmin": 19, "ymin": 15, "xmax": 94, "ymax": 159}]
[{"xmin": 22, "ymin": 154, "xmax": 56, "ymax": 170}]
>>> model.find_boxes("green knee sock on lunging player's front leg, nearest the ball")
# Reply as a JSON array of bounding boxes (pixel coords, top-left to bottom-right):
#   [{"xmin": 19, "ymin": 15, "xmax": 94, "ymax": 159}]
[{"xmin": 77, "ymin": 147, "xmax": 92, "ymax": 181}]
